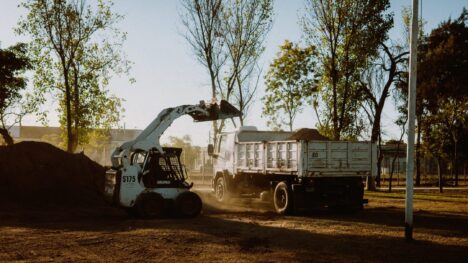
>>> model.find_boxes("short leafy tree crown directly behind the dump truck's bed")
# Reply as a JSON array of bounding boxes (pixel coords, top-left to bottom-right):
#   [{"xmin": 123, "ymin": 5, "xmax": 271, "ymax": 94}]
[{"xmin": 263, "ymin": 40, "xmax": 317, "ymax": 131}]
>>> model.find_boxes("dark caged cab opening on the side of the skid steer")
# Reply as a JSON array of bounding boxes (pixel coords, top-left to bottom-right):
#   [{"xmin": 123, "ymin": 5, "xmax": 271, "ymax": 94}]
[{"xmin": 142, "ymin": 150, "xmax": 185, "ymax": 188}]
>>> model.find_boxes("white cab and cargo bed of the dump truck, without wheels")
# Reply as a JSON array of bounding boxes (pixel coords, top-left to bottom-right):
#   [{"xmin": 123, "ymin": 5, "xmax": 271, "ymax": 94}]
[{"xmin": 215, "ymin": 131, "xmax": 377, "ymax": 177}]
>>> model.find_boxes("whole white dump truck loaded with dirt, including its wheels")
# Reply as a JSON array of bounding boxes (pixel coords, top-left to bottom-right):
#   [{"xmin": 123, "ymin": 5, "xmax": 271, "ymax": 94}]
[{"xmin": 208, "ymin": 127, "xmax": 377, "ymax": 214}]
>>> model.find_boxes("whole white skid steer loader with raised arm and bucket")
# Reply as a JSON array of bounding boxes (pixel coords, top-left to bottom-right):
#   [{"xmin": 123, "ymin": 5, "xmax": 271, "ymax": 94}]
[{"xmin": 104, "ymin": 100, "xmax": 241, "ymax": 218}]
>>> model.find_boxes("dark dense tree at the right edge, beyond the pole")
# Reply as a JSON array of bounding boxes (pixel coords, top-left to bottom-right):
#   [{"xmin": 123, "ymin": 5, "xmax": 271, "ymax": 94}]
[{"xmin": 418, "ymin": 9, "xmax": 468, "ymax": 187}]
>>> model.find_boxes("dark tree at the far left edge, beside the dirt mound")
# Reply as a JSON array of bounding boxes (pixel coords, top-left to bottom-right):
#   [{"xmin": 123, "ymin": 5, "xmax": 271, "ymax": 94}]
[{"xmin": 0, "ymin": 43, "xmax": 35, "ymax": 145}]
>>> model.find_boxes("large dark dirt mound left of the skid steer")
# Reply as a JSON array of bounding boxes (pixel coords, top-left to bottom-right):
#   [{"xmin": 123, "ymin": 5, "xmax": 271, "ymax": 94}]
[{"xmin": 0, "ymin": 142, "xmax": 105, "ymax": 207}]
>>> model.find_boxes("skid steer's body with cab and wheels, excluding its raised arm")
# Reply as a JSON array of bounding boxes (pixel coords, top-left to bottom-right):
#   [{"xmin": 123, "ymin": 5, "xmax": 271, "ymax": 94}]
[{"xmin": 104, "ymin": 147, "xmax": 202, "ymax": 218}]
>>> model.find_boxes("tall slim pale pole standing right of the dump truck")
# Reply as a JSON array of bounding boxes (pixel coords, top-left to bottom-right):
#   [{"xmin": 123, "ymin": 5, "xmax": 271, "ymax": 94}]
[{"xmin": 405, "ymin": 0, "xmax": 419, "ymax": 240}]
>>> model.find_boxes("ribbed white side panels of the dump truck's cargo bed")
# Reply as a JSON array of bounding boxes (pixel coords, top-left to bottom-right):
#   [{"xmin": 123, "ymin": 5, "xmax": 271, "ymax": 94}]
[{"xmin": 234, "ymin": 140, "xmax": 377, "ymax": 177}]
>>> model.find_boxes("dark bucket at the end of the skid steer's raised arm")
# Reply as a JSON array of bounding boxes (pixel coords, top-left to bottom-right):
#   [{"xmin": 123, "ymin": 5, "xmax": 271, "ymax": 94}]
[{"xmin": 190, "ymin": 100, "xmax": 242, "ymax": 122}]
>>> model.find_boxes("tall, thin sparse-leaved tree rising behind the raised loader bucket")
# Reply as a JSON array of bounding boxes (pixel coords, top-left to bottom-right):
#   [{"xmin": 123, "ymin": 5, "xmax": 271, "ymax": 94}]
[{"xmin": 181, "ymin": 0, "xmax": 273, "ymax": 137}]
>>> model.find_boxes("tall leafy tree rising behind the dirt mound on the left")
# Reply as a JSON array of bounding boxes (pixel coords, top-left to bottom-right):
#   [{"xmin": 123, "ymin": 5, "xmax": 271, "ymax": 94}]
[{"xmin": 17, "ymin": 0, "xmax": 130, "ymax": 152}]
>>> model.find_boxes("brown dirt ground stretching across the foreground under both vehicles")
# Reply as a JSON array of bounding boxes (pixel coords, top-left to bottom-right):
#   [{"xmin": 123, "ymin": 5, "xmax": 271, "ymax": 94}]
[{"xmin": 0, "ymin": 192, "xmax": 468, "ymax": 262}]
